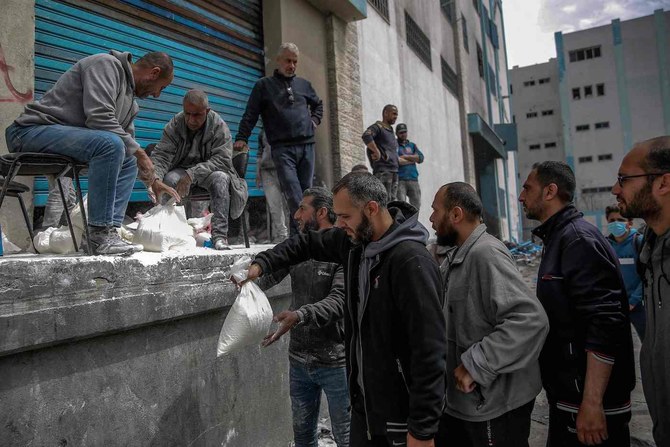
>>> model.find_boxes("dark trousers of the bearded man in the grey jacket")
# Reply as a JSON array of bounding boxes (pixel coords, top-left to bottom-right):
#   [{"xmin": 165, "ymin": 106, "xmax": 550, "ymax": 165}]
[{"xmin": 435, "ymin": 399, "xmax": 535, "ymax": 447}]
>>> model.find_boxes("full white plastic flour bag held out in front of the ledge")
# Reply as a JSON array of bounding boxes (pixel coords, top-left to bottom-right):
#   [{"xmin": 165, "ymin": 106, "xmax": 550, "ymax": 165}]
[{"xmin": 216, "ymin": 256, "xmax": 272, "ymax": 357}]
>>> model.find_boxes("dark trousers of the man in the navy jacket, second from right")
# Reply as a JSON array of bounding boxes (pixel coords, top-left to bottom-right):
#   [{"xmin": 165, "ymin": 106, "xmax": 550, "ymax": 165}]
[{"xmin": 547, "ymin": 404, "xmax": 631, "ymax": 447}]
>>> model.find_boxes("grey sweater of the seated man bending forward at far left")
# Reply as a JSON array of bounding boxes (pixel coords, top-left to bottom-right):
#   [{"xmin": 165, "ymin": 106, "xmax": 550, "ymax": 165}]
[{"xmin": 15, "ymin": 50, "xmax": 140, "ymax": 154}]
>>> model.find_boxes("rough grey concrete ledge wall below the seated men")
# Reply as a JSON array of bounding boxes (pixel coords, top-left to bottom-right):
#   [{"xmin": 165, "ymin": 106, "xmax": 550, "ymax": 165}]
[{"xmin": 0, "ymin": 249, "xmax": 292, "ymax": 447}]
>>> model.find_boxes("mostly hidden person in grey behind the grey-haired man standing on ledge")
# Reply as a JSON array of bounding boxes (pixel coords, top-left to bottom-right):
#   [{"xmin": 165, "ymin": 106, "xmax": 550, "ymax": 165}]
[{"xmin": 256, "ymin": 130, "xmax": 288, "ymax": 244}]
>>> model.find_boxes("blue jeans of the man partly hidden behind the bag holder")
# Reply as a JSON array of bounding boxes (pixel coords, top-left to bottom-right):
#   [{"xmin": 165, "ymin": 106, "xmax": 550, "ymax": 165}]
[{"xmin": 290, "ymin": 359, "xmax": 351, "ymax": 447}]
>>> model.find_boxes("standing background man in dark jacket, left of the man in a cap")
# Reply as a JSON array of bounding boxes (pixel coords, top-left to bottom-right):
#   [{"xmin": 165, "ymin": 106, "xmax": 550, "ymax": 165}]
[{"xmin": 362, "ymin": 104, "xmax": 398, "ymax": 201}]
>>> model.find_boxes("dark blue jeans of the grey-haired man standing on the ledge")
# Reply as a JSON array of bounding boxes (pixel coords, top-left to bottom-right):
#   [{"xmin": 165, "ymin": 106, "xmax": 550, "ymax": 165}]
[{"xmin": 272, "ymin": 143, "xmax": 314, "ymax": 235}]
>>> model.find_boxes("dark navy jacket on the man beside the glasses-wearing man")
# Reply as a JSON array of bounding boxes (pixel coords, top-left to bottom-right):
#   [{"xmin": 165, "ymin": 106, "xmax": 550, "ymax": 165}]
[{"xmin": 533, "ymin": 205, "xmax": 635, "ymax": 414}]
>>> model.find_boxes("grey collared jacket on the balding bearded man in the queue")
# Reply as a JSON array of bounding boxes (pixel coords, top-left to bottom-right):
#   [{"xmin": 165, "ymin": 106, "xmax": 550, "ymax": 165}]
[{"xmin": 440, "ymin": 224, "xmax": 549, "ymax": 422}]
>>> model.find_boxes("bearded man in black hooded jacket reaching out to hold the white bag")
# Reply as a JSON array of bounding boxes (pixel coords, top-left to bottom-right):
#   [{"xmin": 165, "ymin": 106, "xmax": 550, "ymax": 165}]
[{"xmin": 249, "ymin": 173, "xmax": 447, "ymax": 447}]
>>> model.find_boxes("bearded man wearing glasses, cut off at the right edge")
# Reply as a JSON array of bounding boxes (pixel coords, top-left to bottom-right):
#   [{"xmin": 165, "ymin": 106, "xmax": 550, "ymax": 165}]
[{"xmin": 612, "ymin": 136, "xmax": 670, "ymax": 446}]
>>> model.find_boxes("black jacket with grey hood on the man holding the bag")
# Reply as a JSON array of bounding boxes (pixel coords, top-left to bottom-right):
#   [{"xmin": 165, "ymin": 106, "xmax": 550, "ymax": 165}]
[{"xmin": 255, "ymin": 202, "xmax": 447, "ymax": 439}]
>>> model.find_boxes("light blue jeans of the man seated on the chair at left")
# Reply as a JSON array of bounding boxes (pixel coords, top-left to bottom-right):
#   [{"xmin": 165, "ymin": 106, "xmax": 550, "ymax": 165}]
[{"xmin": 5, "ymin": 124, "xmax": 137, "ymax": 227}]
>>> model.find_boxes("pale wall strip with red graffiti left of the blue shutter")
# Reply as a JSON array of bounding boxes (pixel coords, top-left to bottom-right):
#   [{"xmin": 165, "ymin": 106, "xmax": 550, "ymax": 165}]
[{"xmin": 0, "ymin": 0, "xmax": 35, "ymax": 247}]
